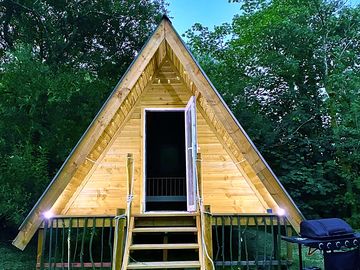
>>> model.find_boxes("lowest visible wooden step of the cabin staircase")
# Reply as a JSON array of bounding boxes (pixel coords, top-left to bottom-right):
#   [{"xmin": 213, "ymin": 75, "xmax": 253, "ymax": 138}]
[{"xmin": 127, "ymin": 261, "xmax": 200, "ymax": 269}]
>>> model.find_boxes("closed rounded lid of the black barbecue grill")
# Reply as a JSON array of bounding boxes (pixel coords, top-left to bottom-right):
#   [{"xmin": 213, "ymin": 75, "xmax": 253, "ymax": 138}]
[{"xmin": 300, "ymin": 218, "xmax": 354, "ymax": 239}]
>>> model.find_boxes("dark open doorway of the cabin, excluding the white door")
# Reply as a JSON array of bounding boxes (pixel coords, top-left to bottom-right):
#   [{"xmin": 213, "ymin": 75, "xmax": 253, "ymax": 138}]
[{"xmin": 145, "ymin": 110, "xmax": 187, "ymax": 211}]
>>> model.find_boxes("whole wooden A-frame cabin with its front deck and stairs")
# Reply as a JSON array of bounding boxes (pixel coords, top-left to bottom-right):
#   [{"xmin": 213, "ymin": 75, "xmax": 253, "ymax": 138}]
[{"xmin": 13, "ymin": 17, "xmax": 303, "ymax": 269}]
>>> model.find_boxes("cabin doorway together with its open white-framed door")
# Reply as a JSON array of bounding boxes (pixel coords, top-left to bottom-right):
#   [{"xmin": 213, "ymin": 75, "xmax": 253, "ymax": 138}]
[{"xmin": 144, "ymin": 98, "xmax": 197, "ymax": 211}]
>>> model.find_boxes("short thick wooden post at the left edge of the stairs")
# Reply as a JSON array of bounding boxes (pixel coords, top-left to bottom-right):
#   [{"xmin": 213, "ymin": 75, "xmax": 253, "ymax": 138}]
[{"xmin": 112, "ymin": 209, "xmax": 126, "ymax": 270}]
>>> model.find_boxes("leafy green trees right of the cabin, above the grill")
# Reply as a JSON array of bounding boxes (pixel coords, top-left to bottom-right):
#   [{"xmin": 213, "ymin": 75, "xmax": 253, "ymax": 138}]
[{"xmin": 186, "ymin": 0, "xmax": 360, "ymax": 226}]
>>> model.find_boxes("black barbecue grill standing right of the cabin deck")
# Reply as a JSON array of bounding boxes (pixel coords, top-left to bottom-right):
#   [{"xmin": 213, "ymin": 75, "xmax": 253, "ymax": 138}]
[{"xmin": 283, "ymin": 218, "xmax": 360, "ymax": 270}]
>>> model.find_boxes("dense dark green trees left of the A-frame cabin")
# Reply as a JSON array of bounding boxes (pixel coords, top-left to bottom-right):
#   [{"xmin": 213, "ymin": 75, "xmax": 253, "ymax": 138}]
[{"xmin": 0, "ymin": 0, "xmax": 165, "ymax": 229}]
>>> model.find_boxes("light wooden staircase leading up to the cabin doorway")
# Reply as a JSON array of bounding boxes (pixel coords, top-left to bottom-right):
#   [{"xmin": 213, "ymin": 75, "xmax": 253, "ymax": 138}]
[{"xmin": 122, "ymin": 213, "xmax": 204, "ymax": 270}]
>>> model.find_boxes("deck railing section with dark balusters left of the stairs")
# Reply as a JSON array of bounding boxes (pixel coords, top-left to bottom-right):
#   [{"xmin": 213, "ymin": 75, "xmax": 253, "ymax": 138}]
[{"xmin": 36, "ymin": 216, "xmax": 115, "ymax": 269}]
